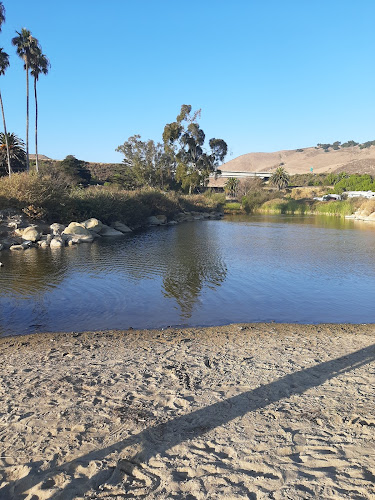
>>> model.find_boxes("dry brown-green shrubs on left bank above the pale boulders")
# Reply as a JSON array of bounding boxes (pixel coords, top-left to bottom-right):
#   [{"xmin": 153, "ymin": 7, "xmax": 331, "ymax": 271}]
[{"xmin": 0, "ymin": 173, "xmax": 222, "ymax": 227}]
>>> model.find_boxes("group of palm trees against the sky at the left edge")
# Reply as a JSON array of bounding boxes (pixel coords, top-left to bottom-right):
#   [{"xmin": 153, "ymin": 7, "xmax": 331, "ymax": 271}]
[{"xmin": 0, "ymin": 2, "xmax": 50, "ymax": 176}]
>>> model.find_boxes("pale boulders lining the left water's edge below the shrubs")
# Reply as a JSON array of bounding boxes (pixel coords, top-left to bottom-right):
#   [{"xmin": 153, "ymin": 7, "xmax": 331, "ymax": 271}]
[{"xmin": 0, "ymin": 210, "xmax": 222, "ymax": 258}]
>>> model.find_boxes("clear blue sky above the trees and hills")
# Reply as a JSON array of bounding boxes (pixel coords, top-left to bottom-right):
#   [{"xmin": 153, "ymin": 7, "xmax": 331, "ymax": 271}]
[{"xmin": 0, "ymin": 0, "xmax": 375, "ymax": 162}]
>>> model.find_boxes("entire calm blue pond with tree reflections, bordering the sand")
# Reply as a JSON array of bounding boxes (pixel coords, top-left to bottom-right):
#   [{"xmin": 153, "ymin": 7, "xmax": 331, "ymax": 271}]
[{"xmin": 0, "ymin": 216, "xmax": 375, "ymax": 335}]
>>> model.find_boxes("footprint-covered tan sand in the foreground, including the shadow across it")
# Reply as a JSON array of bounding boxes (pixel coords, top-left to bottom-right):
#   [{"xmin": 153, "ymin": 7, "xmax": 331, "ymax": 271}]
[{"xmin": 0, "ymin": 324, "xmax": 375, "ymax": 500}]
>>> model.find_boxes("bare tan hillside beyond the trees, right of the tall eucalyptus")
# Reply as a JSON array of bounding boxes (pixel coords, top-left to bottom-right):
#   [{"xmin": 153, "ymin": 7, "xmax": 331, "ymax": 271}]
[{"xmin": 220, "ymin": 146, "xmax": 375, "ymax": 175}]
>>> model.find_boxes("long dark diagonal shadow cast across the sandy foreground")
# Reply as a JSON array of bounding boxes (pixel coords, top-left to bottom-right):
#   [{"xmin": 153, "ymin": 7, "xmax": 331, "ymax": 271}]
[{"xmin": 0, "ymin": 344, "xmax": 375, "ymax": 500}]
